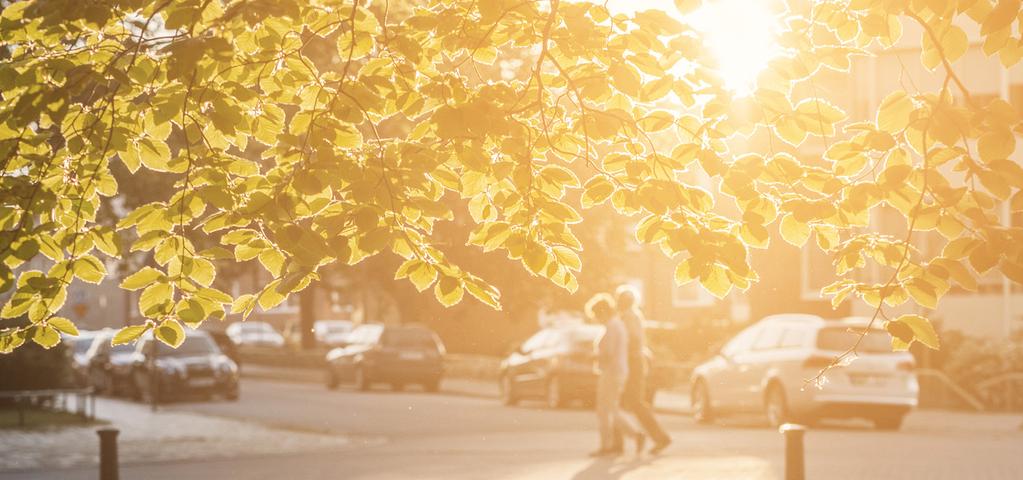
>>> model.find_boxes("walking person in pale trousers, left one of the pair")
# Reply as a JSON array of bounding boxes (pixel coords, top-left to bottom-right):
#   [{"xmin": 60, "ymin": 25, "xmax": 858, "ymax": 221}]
[{"xmin": 586, "ymin": 294, "xmax": 646, "ymax": 456}]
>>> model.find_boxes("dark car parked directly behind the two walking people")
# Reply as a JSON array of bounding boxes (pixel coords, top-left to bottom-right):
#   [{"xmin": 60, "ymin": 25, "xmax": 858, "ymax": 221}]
[{"xmin": 499, "ymin": 323, "xmax": 668, "ymax": 408}]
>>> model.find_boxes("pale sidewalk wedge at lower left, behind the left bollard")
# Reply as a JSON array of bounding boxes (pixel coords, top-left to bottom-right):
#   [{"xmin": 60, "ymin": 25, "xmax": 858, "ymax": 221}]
[{"xmin": 0, "ymin": 397, "xmax": 366, "ymax": 472}]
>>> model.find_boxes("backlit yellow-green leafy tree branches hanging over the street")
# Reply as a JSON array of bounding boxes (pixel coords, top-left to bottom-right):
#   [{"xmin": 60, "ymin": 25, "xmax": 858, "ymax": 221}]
[{"xmin": 0, "ymin": 0, "xmax": 1023, "ymax": 362}]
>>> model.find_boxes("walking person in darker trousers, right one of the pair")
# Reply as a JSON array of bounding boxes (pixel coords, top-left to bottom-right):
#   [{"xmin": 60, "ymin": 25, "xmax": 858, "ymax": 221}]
[{"xmin": 615, "ymin": 286, "xmax": 671, "ymax": 454}]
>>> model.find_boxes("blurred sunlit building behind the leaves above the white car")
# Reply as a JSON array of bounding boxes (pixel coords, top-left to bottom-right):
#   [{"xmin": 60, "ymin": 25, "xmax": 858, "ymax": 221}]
[{"xmin": 623, "ymin": 21, "xmax": 1023, "ymax": 339}]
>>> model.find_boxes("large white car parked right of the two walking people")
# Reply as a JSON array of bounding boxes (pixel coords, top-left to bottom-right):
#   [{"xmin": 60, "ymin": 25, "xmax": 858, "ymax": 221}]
[{"xmin": 692, "ymin": 313, "xmax": 920, "ymax": 430}]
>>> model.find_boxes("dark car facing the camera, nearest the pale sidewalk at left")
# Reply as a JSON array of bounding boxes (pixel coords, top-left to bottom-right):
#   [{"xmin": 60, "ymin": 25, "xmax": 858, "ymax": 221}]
[{"xmin": 132, "ymin": 331, "xmax": 238, "ymax": 402}]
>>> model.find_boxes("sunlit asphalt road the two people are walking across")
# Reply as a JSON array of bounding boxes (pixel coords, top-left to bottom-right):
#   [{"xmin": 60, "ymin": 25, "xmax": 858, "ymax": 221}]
[{"xmin": 8, "ymin": 380, "xmax": 1023, "ymax": 480}]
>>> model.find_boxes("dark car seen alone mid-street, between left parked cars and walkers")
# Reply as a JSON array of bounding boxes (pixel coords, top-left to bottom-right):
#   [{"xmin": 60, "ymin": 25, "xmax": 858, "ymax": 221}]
[{"xmin": 326, "ymin": 324, "xmax": 444, "ymax": 392}]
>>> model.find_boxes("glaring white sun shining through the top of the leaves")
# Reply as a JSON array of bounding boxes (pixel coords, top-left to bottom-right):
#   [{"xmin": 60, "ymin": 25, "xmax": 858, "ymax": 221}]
[{"xmin": 686, "ymin": 0, "xmax": 780, "ymax": 95}]
